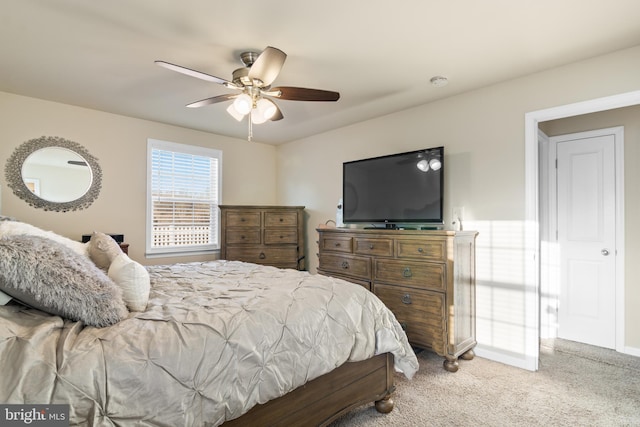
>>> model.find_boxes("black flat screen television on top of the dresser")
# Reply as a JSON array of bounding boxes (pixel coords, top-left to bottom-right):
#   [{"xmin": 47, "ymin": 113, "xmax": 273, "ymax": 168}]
[{"xmin": 342, "ymin": 147, "xmax": 444, "ymax": 228}]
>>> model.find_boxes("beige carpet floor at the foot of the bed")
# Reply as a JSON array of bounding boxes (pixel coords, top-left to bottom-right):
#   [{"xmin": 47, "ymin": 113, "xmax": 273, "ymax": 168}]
[{"xmin": 332, "ymin": 340, "xmax": 640, "ymax": 427}]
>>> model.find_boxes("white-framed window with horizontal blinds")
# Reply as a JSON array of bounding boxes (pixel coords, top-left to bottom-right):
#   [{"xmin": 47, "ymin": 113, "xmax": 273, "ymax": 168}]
[{"xmin": 146, "ymin": 139, "xmax": 222, "ymax": 256}]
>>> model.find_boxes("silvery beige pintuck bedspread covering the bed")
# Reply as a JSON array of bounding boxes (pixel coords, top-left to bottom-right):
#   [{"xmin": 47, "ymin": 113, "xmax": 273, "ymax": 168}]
[{"xmin": 0, "ymin": 261, "xmax": 418, "ymax": 426}]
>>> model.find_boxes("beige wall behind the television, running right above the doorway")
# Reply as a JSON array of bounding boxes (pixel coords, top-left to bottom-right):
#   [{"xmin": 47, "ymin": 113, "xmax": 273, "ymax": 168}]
[{"xmin": 277, "ymin": 47, "xmax": 640, "ymax": 365}]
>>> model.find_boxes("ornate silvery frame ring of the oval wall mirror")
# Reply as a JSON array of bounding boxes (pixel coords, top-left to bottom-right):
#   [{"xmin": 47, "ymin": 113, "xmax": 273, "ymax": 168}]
[{"xmin": 4, "ymin": 136, "xmax": 102, "ymax": 212}]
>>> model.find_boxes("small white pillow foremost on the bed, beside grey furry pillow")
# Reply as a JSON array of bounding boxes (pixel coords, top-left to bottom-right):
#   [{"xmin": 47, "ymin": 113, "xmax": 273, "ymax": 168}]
[{"xmin": 108, "ymin": 252, "xmax": 151, "ymax": 311}]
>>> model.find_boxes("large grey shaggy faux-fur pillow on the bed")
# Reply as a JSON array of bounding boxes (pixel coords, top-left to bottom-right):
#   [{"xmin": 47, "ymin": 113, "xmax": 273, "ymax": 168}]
[{"xmin": 0, "ymin": 235, "xmax": 127, "ymax": 327}]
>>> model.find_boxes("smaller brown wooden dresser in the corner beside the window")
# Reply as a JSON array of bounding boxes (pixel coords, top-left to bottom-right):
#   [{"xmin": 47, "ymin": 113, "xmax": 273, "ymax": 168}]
[{"xmin": 220, "ymin": 205, "xmax": 305, "ymax": 270}]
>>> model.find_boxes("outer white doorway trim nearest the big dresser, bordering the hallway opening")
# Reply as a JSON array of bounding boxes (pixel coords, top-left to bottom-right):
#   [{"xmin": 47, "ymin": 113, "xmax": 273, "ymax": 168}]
[{"xmin": 522, "ymin": 91, "xmax": 640, "ymax": 371}]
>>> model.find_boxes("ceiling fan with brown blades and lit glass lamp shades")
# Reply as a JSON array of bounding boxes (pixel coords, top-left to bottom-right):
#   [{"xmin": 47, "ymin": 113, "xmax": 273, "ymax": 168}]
[{"xmin": 155, "ymin": 46, "xmax": 340, "ymax": 140}]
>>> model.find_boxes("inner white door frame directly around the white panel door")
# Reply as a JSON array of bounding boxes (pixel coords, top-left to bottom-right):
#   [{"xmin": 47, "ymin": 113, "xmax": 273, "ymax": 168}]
[{"xmin": 540, "ymin": 126, "xmax": 625, "ymax": 352}]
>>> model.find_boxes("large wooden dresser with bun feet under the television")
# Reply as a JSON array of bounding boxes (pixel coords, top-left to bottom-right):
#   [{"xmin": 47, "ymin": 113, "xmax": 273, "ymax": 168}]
[{"xmin": 317, "ymin": 228, "xmax": 477, "ymax": 372}]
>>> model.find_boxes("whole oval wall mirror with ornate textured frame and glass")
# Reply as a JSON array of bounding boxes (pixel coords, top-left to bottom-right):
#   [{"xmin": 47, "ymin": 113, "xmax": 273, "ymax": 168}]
[{"xmin": 5, "ymin": 136, "xmax": 102, "ymax": 212}]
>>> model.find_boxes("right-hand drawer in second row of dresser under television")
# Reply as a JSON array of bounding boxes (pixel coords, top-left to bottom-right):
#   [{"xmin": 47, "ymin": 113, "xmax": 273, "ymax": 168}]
[{"xmin": 373, "ymin": 259, "xmax": 446, "ymax": 291}]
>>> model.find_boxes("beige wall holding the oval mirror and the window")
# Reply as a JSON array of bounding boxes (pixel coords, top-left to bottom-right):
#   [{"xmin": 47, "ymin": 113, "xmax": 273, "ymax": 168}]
[{"xmin": 0, "ymin": 92, "xmax": 276, "ymax": 264}]
